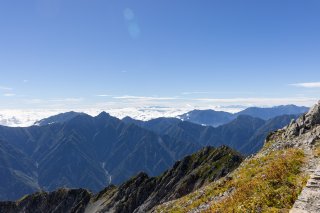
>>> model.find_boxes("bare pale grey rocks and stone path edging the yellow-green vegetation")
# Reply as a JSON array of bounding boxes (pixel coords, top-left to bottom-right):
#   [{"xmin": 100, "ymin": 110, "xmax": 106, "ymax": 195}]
[{"xmin": 268, "ymin": 101, "xmax": 320, "ymax": 213}]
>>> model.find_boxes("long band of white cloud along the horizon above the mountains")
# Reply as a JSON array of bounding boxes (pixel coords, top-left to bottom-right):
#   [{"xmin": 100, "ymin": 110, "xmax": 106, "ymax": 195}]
[{"xmin": 0, "ymin": 92, "xmax": 318, "ymax": 126}]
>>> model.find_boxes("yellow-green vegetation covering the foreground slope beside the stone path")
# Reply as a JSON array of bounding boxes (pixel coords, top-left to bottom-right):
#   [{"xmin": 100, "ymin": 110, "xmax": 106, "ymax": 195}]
[{"xmin": 157, "ymin": 148, "xmax": 307, "ymax": 213}]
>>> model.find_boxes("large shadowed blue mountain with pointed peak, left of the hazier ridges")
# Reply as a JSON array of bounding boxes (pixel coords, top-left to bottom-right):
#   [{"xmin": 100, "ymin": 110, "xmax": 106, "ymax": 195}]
[{"xmin": 0, "ymin": 113, "xmax": 201, "ymax": 199}]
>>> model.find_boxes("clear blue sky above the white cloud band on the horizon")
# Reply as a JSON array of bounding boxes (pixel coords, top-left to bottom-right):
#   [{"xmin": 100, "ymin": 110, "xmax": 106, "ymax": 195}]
[{"xmin": 0, "ymin": 0, "xmax": 320, "ymax": 109}]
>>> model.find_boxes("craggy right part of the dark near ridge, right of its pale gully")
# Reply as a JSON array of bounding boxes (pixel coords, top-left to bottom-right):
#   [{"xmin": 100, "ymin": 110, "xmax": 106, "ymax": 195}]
[{"xmin": 92, "ymin": 146, "xmax": 242, "ymax": 213}]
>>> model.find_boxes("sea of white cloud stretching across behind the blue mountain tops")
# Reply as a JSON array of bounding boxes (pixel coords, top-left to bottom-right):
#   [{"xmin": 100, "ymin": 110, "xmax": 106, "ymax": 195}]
[{"xmin": 0, "ymin": 96, "xmax": 317, "ymax": 126}]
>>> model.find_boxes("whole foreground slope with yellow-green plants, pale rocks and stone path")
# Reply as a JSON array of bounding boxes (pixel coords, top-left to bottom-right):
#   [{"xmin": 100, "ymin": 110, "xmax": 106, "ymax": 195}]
[{"xmin": 155, "ymin": 102, "xmax": 320, "ymax": 213}]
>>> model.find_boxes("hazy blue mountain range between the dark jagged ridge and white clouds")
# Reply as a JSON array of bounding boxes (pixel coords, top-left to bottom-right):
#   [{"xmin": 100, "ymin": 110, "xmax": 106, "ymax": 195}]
[{"xmin": 0, "ymin": 105, "xmax": 308, "ymax": 200}]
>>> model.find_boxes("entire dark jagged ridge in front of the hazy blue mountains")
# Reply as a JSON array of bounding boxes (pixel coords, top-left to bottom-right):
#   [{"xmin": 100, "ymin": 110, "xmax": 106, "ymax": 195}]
[{"xmin": 0, "ymin": 146, "xmax": 243, "ymax": 213}]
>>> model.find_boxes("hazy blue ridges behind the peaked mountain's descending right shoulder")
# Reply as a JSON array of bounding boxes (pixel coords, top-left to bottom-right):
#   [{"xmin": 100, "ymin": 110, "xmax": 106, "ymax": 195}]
[{"xmin": 124, "ymin": 115, "xmax": 298, "ymax": 155}]
